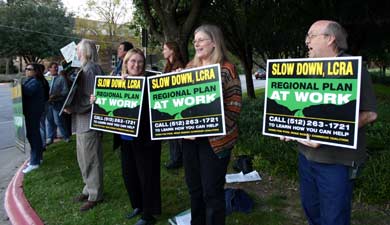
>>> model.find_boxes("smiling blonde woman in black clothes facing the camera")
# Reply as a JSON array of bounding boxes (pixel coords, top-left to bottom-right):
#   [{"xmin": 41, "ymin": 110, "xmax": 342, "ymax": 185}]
[{"xmin": 121, "ymin": 48, "xmax": 161, "ymax": 225}]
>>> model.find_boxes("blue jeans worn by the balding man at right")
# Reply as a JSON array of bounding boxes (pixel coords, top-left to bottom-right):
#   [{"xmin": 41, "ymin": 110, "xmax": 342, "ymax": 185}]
[{"xmin": 298, "ymin": 154, "xmax": 353, "ymax": 225}]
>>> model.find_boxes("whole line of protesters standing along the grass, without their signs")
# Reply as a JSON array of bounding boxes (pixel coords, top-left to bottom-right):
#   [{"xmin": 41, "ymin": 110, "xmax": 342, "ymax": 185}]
[{"xmin": 22, "ymin": 20, "xmax": 377, "ymax": 225}]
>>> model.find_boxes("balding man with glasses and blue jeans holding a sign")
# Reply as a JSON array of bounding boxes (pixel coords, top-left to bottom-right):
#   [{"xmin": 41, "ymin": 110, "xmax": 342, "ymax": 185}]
[{"xmin": 280, "ymin": 20, "xmax": 377, "ymax": 225}]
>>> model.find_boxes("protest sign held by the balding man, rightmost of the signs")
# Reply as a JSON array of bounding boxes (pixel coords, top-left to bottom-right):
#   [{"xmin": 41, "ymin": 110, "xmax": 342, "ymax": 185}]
[{"xmin": 263, "ymin": 57, "xmax": 361, "ymax": 149}]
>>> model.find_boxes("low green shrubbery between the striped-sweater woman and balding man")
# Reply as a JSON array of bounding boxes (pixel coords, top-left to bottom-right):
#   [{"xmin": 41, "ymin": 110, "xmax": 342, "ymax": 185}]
[{"xmin": 234, "ymin": 95, "xmax": 297, "ymax": 179}]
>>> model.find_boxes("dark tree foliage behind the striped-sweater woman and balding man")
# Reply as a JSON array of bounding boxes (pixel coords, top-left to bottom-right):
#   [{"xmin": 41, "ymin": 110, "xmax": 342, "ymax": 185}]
[{"xmin": 131, "ymin": 0, "xmax": 390, "ymax": 92}]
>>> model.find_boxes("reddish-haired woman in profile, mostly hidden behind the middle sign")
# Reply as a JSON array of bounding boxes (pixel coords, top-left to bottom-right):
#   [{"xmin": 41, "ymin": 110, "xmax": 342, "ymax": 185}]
[{"xmin": 163, "ymin": 41, "xmax": 184, "ymax": 169}]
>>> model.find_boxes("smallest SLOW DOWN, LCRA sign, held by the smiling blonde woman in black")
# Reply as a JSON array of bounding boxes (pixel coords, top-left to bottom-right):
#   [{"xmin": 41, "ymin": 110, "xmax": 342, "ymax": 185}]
[{"xmin": 90, "ymin": 76, "xmax": 148, "ymax": 137}]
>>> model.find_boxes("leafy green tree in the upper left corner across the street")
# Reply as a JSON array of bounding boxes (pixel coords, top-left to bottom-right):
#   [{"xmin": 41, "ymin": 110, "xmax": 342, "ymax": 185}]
[{"xmin": 0, "ymin": 0, "xmax": 74, "ymax": 62}]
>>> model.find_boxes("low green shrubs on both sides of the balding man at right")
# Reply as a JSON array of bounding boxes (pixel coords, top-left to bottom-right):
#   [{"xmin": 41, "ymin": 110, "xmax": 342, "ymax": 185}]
[{"xmin": 234, "ymin": 85, "xmax": 390, "ymax": 204}]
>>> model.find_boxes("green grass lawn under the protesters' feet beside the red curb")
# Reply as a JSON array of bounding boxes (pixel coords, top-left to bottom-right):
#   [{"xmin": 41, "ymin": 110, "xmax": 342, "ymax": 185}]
[{"xmin": 24, "ymin": 140, "xmax": 300, "ymax": 225}]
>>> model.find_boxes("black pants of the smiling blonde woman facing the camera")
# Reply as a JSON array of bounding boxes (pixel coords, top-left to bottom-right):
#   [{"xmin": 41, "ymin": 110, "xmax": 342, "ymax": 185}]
[{"xmin": 121, "ymin": 140, "xmax": 161, "ymax": 216}]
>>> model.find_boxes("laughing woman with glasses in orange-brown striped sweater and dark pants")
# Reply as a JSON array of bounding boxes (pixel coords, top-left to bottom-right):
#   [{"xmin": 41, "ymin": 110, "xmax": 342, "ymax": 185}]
[{"xmin": 183, "ymin": 25, "xmax": 241, "ymax": 225}]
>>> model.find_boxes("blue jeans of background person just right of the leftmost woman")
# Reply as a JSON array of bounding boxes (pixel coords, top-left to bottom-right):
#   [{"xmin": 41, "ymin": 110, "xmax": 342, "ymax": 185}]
[{"xmin": 46, "ymin": 104, "xmax": 69, "ymax": 140}]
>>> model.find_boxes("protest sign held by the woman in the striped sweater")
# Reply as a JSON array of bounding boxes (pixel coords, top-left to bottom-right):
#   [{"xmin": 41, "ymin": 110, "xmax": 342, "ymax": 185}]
[{"xmin": 148, "ymin": 64, "xmax": 225, "ymax": 140}]
